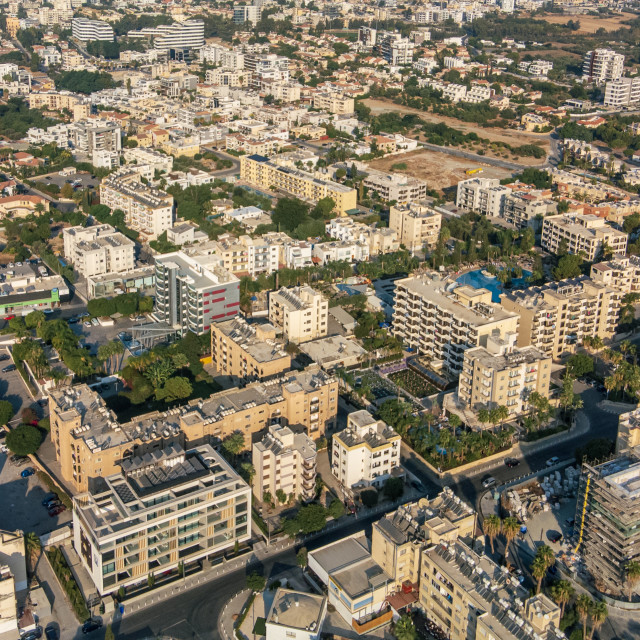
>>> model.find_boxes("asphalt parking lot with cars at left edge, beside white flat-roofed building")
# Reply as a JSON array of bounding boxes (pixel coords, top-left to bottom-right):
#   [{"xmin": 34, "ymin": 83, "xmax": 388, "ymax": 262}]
[{"xmin": 0, "ymin": 453, "xmax": 71, "ymax": 536}]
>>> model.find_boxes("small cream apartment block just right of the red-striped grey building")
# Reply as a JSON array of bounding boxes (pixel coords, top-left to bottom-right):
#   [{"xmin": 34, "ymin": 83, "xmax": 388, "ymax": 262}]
[{"xmin": 269, "ymin": 286, "xmax": 329, "ymax": 343}]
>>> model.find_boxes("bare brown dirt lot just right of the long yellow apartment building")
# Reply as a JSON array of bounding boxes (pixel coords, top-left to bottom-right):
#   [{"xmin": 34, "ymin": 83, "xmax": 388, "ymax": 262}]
[{"xmin": 369, "ymin": 149, "xmax": 511, "ymax": 189}]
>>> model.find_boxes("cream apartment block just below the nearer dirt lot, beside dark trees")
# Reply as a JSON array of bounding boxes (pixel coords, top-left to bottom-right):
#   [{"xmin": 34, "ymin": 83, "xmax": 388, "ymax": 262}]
[{"xmin": 389, "ymin": 201, "xmax": 442, "ymax": 253}]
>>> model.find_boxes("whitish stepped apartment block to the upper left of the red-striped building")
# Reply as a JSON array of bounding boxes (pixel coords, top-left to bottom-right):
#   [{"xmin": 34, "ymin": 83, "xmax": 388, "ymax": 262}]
[{"xmin": 62, "ymin": 224, "xmax": 136, "ymax": 278}]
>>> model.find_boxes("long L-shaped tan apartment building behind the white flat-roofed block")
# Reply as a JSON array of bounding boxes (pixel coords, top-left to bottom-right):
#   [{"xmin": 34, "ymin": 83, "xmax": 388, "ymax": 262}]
[{"xmin": 49, "ymin": 367, "xmax": 338, "ymax": 492}]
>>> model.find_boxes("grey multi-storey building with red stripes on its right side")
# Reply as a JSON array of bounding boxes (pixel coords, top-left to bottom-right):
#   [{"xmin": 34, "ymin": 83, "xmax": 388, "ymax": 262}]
[{"xmin": 155, "ymin": 251, "xmax": 240, "ymax": 335}]
